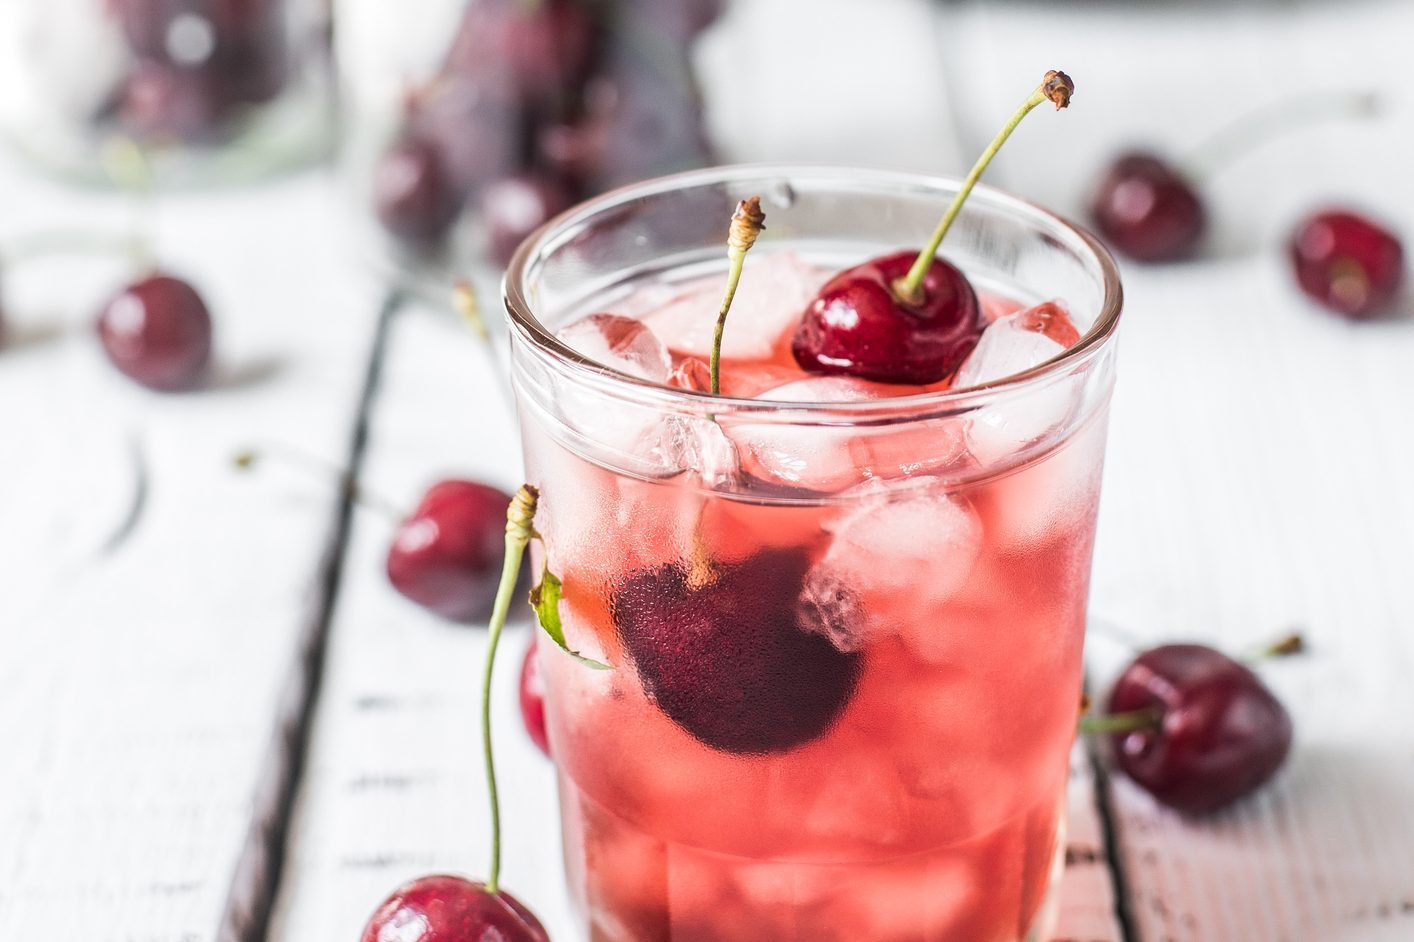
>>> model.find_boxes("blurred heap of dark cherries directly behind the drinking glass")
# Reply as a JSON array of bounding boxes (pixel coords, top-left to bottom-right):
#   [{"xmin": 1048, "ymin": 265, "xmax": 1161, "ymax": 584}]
[{"xmin": 373, "ymin": 0, "xmax": 723, "ymax": 264}]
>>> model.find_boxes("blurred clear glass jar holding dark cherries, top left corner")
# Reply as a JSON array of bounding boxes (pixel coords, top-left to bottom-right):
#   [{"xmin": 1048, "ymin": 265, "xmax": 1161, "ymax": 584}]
[{"xmin": 0, "ymin": 0, "xmax": 332, "ymax": 185}]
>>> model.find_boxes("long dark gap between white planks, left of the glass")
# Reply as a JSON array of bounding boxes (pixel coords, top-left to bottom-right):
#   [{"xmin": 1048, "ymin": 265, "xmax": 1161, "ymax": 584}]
[{"xmin": 216, "ymin": 289, "xmax": 406, "ymax": 942}]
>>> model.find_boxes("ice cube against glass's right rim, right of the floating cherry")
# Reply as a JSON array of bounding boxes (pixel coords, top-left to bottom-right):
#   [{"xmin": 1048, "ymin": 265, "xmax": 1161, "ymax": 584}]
[{"xmin": 953, "ymin": 301, "xmax": 1079, "ymax": 465}]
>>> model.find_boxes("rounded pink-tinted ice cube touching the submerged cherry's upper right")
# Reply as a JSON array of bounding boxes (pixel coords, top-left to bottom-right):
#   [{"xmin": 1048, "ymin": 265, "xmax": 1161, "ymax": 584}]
[{"xmin": 800, "ymin": 485, "xmax": 981, "ymax": 651}]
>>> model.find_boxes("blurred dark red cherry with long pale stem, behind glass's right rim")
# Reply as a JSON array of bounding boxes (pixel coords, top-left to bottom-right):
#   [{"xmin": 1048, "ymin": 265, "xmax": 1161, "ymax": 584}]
[{"xmin": 1090, "ymin": 93, "xmax": 1376, "ymax": 262}]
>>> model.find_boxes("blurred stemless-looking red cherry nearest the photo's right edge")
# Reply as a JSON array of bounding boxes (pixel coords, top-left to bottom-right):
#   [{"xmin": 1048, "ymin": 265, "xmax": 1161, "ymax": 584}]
[{"xmin": 1290, "ymin": 209, "xmax": 1404, "ymax": 320}]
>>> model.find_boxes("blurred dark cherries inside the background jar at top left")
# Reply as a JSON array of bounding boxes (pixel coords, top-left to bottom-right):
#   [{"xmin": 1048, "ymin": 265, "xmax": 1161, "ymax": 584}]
[{"xmin": 103, "ymin": 0, "xmax": 288, "ymax": 143}]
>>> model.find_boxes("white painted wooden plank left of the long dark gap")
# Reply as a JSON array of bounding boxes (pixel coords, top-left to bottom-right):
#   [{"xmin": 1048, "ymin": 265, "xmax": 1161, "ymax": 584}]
[{"xmin": 0, "ymin": 157, "xmax": 373, "ymax": 942}]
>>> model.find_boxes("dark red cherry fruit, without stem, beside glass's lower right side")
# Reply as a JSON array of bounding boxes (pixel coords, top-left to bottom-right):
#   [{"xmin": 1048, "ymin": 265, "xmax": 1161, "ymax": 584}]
[{"xmin": 1109, "ymin": 645, "xmax": 1291, "ymax": 815}]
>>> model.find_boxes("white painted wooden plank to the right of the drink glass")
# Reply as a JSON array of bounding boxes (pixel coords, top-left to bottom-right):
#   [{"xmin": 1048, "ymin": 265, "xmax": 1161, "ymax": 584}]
[{"xmin": 938, "ymin": 3, "xmax": 1414, "ymax": 942}]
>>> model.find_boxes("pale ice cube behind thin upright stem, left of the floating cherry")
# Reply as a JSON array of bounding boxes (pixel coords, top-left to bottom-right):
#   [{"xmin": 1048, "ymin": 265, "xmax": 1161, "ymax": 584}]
[{"xmin": 643, "ymin": 252, "xmax": 829, "ymax": 359}]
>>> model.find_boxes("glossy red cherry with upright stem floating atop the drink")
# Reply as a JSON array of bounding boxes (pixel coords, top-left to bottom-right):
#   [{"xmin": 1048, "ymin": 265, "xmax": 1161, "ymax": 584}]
[{"xmin": 790, "ymin": 71, "xmax": 1075, "ymax": 385}]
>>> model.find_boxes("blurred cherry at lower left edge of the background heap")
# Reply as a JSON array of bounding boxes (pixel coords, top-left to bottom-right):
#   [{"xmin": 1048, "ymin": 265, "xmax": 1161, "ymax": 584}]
[{"xmin": 373, "ymin": 137, "xmax": 462, "ymax": 246}]
